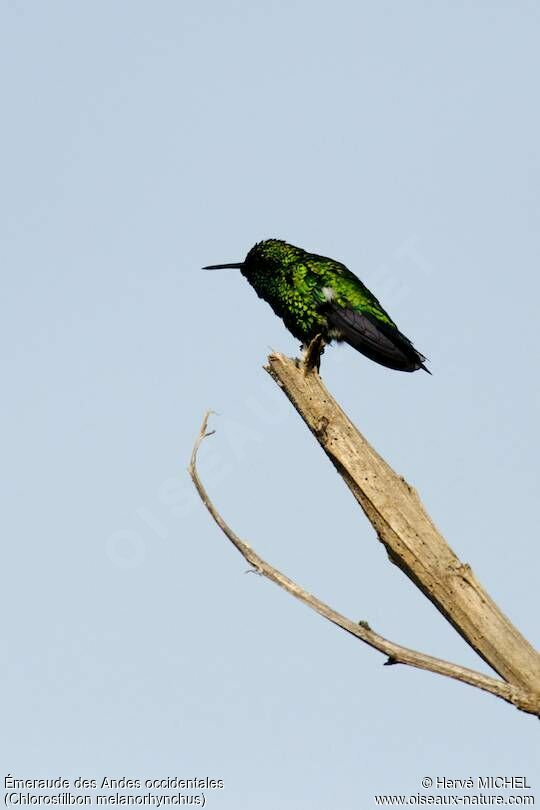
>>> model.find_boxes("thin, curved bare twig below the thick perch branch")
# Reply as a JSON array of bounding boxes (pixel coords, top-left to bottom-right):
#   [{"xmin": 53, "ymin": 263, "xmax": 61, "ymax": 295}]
[{"xmin": 189, "ymin": 413, "xmax": 540, "ymax": 715}]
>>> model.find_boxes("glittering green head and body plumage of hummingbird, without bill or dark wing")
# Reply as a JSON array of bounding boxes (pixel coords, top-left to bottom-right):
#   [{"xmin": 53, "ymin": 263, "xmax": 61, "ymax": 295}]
[{"xmin": 241, "ymin": 239, "xmax": 395, "ymax": 343}]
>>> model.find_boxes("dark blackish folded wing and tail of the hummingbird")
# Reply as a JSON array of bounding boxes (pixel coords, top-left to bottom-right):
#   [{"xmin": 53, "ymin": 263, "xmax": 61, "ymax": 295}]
[{"xmin": 328, "ymin": 304, "xmax": 431, "ymax": 374}]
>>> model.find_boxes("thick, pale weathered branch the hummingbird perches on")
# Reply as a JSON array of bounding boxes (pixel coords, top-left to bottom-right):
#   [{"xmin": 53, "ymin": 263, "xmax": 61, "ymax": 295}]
[{"xmin": 266, "ymin": 354, "xmax": 540, "ymax": 701}]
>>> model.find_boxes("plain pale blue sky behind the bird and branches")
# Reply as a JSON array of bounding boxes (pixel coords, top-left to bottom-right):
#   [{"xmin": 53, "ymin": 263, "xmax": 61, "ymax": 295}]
[{"xmin": 0, "ymin": 0, "xmax": 540, "ymax": 810}]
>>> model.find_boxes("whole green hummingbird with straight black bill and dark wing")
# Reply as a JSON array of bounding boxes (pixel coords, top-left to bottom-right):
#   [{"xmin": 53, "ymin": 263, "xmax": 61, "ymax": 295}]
[{"xmin": 203, "ymin": 239, "xmax": 431, "ymax": 374}]
